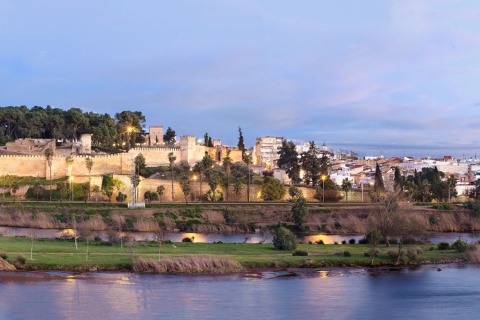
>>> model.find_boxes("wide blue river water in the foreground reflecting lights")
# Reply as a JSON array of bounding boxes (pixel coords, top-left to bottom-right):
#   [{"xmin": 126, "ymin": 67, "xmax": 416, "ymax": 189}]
[{"xmin": 0, "ymin": 264, "xmax": 480, "ymax": 320}]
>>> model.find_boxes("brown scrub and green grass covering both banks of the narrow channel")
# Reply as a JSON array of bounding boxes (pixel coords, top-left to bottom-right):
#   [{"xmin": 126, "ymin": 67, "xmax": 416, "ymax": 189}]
[{"xmin": 0, "ymin": 194, "xmax": 480, "ymax": 274}]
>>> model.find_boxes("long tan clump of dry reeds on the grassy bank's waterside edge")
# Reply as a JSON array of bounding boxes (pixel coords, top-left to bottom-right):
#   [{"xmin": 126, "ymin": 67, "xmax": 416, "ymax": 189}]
[{"xmin": 133, "ymin": 255, "xmax": 243, "ymax": 274}]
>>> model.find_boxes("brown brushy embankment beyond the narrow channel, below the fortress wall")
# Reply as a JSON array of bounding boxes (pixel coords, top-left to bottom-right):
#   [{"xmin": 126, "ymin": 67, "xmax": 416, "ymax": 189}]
[{"xmin": 0, "ymin": 203, "xmax": 474, "ymax": 234}]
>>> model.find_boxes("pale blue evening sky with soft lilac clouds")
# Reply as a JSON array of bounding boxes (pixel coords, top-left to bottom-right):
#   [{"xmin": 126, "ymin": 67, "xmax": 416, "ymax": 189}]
[{"xmin": 0, "ymin": 0, "xmax": 480, "ymax": 157}]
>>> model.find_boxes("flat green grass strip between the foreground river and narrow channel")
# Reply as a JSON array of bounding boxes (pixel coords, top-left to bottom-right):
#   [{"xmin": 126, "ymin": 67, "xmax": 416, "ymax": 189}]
[{"xmin": 0, "ymin": 237, "xmax": 466, "ymax": 273}]
